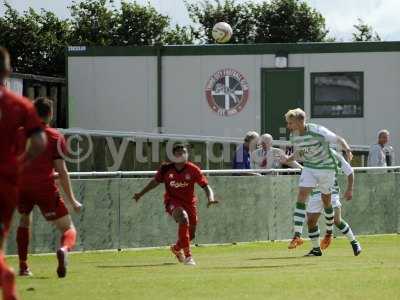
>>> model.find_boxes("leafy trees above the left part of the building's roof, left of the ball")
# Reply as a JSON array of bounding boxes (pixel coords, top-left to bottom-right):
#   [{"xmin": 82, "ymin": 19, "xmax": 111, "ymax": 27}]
[{"xmin": 70, "ymin": 0, "xmax": 194, "ymax": 46}]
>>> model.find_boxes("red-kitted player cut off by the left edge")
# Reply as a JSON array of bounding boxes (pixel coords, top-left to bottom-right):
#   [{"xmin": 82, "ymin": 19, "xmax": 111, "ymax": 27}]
[{"xmin": 0, "ymin": 48, "xmax": 46, "ymax": 300}]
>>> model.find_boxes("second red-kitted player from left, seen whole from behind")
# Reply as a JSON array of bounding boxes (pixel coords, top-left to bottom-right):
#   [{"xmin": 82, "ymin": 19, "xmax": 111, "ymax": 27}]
[{"xmin": 17, "ymin": 98, "xmax": 82, "ymax": 278}]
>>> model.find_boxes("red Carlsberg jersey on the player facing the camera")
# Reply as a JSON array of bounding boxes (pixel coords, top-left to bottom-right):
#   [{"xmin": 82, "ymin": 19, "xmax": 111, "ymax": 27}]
[{"xmin": 154, "ymin": 162, "xmax": 208, "ymax": 204}]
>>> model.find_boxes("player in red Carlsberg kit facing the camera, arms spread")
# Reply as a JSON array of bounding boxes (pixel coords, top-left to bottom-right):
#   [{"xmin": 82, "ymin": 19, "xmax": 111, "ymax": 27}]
[{"xmin": 133, "ymin": 144, "xmax": 218, "ymax": 266}]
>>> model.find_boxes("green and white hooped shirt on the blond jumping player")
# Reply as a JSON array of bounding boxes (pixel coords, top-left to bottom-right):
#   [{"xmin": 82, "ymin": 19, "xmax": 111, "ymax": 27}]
[{"xmin": 290, "ymin": 123, "xmax": 337, "ymax": 170}]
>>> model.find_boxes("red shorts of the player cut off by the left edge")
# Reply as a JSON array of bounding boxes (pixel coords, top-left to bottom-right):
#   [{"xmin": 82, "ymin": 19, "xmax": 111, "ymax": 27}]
[{"xmin": 0, "ymin": 180, "xmax": 18, "ymax": 237}]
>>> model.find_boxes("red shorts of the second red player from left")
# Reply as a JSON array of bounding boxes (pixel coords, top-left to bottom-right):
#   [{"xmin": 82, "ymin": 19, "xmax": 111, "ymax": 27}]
[{"xmin": 18, "ymin": 188, "xmax": 68, "ymax": 221}]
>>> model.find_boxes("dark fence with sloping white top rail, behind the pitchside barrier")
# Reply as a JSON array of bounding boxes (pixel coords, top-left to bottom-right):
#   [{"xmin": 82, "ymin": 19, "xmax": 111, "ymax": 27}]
[{"xmin": 57, "ymin": 129, "xmax": 369, "ymax": 172}]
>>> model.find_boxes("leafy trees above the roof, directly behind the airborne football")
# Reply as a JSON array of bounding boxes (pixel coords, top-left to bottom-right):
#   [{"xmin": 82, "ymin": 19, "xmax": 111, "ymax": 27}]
[{"xmin": 186, "ymin": 0, "xmax": 328, "ymax": 44}]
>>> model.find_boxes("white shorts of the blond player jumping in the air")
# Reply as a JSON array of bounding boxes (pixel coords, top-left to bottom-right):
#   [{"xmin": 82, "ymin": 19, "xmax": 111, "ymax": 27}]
[{"xmin": 299, "ymin": 168, "xmax": 336, "ymax": 194}]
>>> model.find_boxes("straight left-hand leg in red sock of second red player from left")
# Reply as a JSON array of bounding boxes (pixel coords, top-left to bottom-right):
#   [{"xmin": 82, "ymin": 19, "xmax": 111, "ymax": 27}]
[{"xmin": 17, "ymin": 213, "xmax": 32, "ymax": 276}]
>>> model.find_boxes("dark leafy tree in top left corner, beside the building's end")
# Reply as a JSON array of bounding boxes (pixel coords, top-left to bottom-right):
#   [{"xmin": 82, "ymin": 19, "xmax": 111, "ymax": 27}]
[{"xmin": 0, "ymin": 2, "xmax": 69, "ymax": 76}]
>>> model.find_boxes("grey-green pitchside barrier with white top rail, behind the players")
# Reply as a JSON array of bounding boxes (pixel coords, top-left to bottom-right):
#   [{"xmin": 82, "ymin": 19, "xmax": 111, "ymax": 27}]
[{"xmin": 8, "ymin": 166, "xmax": 400, "ymax": 254}]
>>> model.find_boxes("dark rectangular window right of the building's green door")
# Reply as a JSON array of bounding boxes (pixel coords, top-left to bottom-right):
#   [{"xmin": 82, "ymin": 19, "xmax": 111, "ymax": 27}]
[{"xmin": 311, "ymin": 72, "xmax": 364, "ymax": 118}]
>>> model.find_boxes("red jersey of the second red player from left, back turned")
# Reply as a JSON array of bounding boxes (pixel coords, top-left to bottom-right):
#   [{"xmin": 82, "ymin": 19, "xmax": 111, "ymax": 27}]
[{"xmin": 21, "ymin": 125, "xmax": 66, "ymax": 188}]
